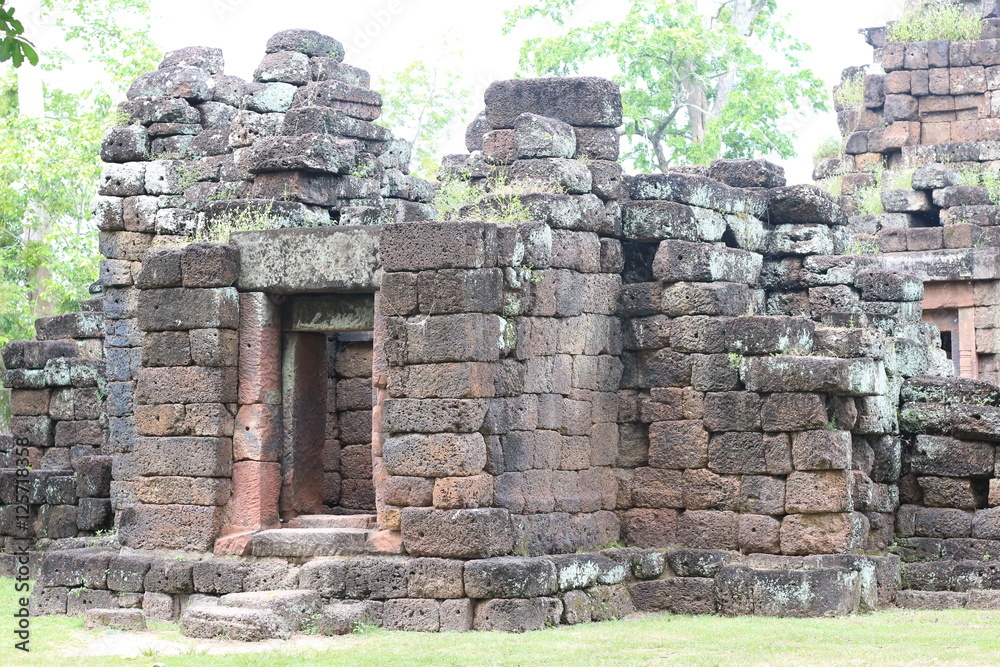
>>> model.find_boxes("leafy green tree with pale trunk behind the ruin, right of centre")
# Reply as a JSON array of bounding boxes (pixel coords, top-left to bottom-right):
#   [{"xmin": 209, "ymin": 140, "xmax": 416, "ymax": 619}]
[{"xmin": 504, "ymin": 0, "xmax": 826, "ymax": 171}]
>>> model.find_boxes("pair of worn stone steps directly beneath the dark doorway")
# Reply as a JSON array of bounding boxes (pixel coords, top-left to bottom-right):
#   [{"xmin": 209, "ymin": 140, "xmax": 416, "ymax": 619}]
[{"xmin": 251, "ymin": 514, "xmax": 403, "ymax": 558}]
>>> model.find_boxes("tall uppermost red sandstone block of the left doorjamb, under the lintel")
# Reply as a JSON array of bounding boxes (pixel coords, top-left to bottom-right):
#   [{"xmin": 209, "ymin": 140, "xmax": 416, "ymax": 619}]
[{"xmin": 239, "ymin": 292, "xmax": 281, "ymax": 405}]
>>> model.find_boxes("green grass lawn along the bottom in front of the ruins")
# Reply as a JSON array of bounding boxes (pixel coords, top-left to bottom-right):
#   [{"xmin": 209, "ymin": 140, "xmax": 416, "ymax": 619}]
[{"xmin": 0, "ymin": 580, "xmax": 1000, "ymax": 667}]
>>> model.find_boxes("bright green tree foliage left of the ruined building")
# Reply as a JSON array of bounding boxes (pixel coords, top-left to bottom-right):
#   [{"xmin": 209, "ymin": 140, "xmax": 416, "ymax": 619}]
[{"xmin": 0, "ymin": 0, "xmax": 159, "ymax": 345}]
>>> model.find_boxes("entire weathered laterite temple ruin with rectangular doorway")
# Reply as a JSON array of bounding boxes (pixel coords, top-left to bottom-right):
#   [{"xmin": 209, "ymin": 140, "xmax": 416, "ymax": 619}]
[{"xmin": 0, "ymin": 17, "xmax": 1000, "ymax": 639}]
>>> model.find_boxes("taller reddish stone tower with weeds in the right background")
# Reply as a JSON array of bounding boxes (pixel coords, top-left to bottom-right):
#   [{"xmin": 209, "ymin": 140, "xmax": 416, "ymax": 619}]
[{"xmin": 814, "ymin": 2, "xmax": 1000, "ymax": 381}]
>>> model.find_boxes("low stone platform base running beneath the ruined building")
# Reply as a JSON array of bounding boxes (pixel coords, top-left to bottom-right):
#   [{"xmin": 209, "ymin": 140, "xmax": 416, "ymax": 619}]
[{"xmin": 31, "ymin": 548, "xmax": 899, "ymax": 641}]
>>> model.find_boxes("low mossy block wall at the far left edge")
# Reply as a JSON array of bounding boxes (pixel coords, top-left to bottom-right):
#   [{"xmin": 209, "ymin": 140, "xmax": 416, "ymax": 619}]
[{"xmin": 0, "ymin": 299, "xmax": 113, "ymax": 553}]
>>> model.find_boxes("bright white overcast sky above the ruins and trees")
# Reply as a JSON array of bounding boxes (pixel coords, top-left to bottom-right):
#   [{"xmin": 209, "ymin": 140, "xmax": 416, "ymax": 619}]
[{"xmin": 135, "ymin": 0, "xmax": 916, "ymax": 182}]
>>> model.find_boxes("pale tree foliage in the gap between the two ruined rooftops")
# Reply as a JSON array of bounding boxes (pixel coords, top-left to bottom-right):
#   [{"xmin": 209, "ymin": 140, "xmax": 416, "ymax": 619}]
[{"xmin": 378, "ymin": 51, "xmax": 470, "ymax": 179}]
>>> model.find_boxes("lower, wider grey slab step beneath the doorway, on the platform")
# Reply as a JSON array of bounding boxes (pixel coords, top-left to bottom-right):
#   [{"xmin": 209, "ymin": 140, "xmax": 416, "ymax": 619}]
[{"xmin": 251, "ymin": 528, "xmax": 402, "ymax": 558}]
